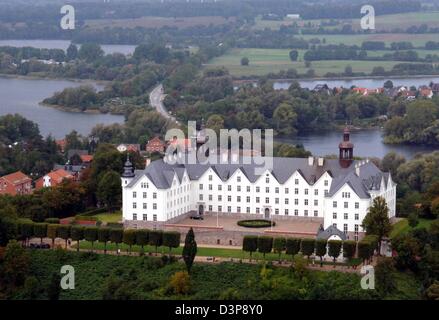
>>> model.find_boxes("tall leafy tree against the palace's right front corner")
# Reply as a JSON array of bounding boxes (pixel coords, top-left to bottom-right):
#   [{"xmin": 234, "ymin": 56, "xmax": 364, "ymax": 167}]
[{"xmin": 362, "ymin": 197, "xmax": 392, "ymax": 252}]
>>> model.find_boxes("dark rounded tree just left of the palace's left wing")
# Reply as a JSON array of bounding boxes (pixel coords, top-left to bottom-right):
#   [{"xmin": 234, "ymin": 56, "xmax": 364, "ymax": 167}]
[{"xmin": 96, "ymin": 171, "xmax": 122, "ymax": 211}]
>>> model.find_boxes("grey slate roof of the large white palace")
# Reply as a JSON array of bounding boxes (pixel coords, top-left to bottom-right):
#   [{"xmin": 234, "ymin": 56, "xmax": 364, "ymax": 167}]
[{"xmin": 128, "ymin": 158, "xmax": 389, "ymax": 198}]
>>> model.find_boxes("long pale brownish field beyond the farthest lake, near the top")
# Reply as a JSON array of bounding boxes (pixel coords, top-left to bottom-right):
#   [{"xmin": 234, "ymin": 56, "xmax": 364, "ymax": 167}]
[{"xmin": 85, "ymin": 16, "xmax": 233, "ymax": 29}]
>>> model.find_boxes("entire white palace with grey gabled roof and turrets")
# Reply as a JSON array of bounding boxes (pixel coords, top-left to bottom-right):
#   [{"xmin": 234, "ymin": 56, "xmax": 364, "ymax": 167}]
[{"xmin": 122, "ymin": 129, "xmax": 396, "ymax": 239}]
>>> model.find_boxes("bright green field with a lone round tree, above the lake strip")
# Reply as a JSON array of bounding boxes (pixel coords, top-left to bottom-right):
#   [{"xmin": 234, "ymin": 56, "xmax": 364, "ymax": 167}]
[{"xmin": 205, "ymin": 48, "xmax": 406, "ymax": 77}]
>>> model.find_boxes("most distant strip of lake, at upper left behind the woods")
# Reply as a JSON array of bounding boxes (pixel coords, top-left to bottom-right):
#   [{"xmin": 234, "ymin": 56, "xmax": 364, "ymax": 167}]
[{"xmin": 0, "ymin": 40, "xmax": 136, "ymax": 55}]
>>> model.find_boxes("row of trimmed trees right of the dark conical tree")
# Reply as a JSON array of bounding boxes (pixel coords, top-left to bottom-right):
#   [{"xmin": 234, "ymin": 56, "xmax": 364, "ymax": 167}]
[{"xmin": 242, "ymin": 235, "xmax": 378, "ymax": 265}]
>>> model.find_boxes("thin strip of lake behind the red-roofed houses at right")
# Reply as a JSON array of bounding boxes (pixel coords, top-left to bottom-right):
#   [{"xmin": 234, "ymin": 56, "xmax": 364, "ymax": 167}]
[{"xmin": 273, "ymin": 76, "xmax": 439, "ymax": 90}]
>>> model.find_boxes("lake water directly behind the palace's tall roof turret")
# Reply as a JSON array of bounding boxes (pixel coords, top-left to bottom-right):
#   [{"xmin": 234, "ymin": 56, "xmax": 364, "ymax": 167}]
[{"xmin": 276, "ymin": 129, "xmax": 439, "ymax": 159}]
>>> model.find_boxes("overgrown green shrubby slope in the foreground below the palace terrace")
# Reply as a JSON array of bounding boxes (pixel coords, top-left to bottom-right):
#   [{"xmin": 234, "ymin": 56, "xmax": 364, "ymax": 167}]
[{"xmin": 12, "ymin": 250, "xmax": 420, "ymax": 300}]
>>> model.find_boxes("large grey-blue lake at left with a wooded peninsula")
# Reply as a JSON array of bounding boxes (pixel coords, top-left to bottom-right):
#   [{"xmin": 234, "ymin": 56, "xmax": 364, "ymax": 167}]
[{"xmin": 0, "ymin": 77, "xmax": 124, "ymax": 139}]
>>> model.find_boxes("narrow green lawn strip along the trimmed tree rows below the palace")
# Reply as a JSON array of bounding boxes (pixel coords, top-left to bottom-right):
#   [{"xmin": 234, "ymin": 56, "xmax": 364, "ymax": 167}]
[{"xmin": 79, "ymin": 241, "xmax": 361, "ymax": 265}]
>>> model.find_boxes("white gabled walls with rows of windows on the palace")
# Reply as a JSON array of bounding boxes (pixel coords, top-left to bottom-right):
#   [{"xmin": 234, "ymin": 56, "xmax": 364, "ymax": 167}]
[{"xmin": 122, "ymin": 159, "xmax": 396, "ymax": 236}]
